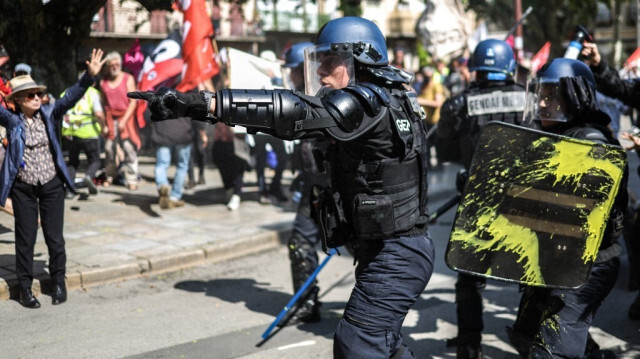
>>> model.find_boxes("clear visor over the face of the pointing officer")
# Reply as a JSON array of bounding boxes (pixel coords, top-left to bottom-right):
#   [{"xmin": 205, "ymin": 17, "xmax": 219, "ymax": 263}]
[{"xmin": 304, "ymin": 43, "xmax": 355, "ymax": 96}]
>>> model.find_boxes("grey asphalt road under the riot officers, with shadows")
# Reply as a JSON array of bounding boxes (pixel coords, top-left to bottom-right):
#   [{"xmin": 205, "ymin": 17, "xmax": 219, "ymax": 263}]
[{"xmin": 0, "ymin": 164, "xmax": 640, "ymax": 359}]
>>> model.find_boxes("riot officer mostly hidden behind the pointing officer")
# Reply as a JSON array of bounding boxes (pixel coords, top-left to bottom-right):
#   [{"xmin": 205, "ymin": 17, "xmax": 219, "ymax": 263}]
[{"xmin": 283, "ymin": 42, "xmax": 329, "ymax": 324}]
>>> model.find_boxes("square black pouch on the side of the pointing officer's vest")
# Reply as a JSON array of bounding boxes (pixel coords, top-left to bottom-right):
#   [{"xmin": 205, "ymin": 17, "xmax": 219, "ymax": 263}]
[{"xmin": 353, "ymin": 193, "xmax": 395, "ymax": 241}]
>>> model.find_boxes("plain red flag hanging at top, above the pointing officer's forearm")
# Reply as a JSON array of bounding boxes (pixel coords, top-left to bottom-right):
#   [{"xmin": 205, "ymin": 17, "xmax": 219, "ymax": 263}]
[{"xmin": 175, "ymin": 0, "xmax": 220, "ymax": 91}]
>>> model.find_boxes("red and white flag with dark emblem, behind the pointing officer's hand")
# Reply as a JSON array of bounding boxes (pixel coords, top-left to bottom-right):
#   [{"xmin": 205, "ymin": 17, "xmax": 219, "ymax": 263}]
[{"xmin": 136, "ymin": 30, "xmax": 184, "ymax": 128}]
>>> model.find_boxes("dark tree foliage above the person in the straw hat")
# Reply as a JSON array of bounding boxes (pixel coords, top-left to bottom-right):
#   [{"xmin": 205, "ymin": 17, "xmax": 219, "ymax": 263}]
[{"xmin": 0, "ymin": 0, "xmax": 106, "ymax": 94}]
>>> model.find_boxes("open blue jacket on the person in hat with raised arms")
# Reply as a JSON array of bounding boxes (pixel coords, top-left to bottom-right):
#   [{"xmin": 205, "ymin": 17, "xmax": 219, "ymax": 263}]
[{"xmin": 0, "ymin": 73, "xmax": 94, "ymax": 206}]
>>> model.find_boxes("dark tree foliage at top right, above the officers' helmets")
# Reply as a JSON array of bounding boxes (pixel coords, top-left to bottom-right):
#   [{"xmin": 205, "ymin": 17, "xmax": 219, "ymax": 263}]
[{"xmin": 466, "ymin": 0, "xmax": 598, "ymax": 57}]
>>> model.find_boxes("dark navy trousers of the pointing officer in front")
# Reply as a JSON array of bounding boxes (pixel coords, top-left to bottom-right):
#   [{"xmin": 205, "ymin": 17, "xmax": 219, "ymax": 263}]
[{"xmin": 333, "ymin": 232, "xmax": 434, "ymax": 359}]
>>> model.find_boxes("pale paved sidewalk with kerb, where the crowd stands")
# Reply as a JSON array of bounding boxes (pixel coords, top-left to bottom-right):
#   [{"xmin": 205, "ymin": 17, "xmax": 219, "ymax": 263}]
[{"xmin": 0, "ymin": 157, "xmax": 458, "ymax": 300}]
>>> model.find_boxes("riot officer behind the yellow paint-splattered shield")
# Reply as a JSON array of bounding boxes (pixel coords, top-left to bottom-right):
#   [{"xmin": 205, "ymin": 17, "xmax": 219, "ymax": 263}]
[{"xmin": 509, "ymin": 58, "xmax": 628, "ymax": 358}]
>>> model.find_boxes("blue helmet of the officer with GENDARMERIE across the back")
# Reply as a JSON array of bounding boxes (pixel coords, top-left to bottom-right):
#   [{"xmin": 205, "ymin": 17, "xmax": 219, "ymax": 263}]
[{"xmin": 469, "ymin": 39, "xmax": 516, "ymax": 80}]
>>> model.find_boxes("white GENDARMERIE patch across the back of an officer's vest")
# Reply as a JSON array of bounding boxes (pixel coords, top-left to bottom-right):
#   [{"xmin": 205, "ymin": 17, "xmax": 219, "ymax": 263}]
[{"xmin": 467, "ymin": 91, "xmax": 524, "ymax": 116}]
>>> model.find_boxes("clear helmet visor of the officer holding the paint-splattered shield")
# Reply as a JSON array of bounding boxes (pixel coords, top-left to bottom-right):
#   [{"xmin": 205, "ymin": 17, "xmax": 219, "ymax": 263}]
[{"xmin": 524, "ymin": 80, "xmax": 569, "ymax": 124}]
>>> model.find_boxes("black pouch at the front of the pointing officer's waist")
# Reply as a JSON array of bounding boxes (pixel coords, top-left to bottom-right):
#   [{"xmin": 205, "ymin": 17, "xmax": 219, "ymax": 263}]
[{"xmin": 311, "ymin": 185, "xmax": 353, "ymax": 253}]
